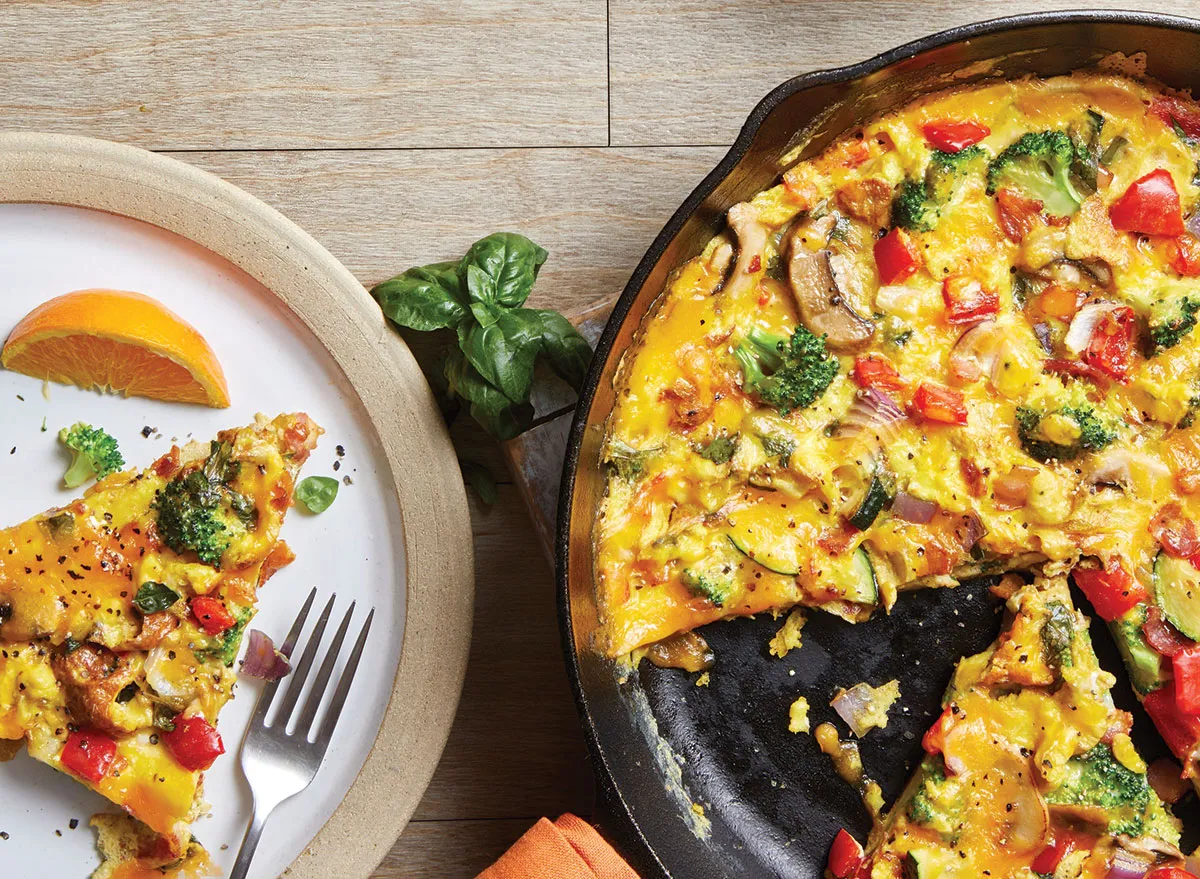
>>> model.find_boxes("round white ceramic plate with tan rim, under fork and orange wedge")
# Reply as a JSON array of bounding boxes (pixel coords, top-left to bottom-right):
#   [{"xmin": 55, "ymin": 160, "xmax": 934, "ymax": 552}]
[{"xmin": 0, "ymin": 130, "xmax": 470, "ymax": 879}]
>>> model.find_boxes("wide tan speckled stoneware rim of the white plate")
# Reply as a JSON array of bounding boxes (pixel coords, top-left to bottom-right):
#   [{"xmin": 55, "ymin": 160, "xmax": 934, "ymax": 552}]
[{"xmin": 0, "ymin": 132, "xmax": 474, "ymax": 879}]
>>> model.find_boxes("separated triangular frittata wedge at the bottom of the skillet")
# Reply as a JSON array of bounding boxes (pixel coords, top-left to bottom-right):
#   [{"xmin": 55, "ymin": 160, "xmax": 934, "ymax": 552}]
[{"xmin": 859, "ymin": 578, "xmax": 1183, "ymax": 879}]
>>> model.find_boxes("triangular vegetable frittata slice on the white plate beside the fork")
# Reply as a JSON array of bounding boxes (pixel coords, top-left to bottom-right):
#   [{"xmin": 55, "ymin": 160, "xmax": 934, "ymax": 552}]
[{"xmin": 0, "ymin": 414, "xmax": 322, "ymax": 874}]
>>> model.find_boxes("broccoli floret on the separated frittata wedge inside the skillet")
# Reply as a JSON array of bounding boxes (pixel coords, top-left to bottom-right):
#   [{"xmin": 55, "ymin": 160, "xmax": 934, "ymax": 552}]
[{"xmin": 1046, "ymin": 743, "xmax": 1177, "ymax": 842}]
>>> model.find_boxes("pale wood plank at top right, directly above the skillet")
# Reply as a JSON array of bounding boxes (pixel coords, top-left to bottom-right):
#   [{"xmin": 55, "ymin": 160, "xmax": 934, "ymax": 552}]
[{"xmin": 610, "ymin": 0, "xmax": 1200, "ymax": 147}]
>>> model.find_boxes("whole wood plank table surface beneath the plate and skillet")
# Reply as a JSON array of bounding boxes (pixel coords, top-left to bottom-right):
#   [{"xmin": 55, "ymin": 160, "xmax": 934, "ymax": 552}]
[{"xmin": 0, "ymin": 0, "xmax": 1200, "ymax": 879}]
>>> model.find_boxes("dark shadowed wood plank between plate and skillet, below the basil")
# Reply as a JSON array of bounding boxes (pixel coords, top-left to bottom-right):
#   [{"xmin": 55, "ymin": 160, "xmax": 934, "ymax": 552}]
[{"xmin": 415, "ymin": 485, "xmax": 593, "ymax": 821}]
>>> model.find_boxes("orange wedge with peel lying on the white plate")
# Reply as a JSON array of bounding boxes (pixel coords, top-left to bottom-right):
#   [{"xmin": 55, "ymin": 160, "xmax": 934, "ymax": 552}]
[{"xmin": 0, "ymin": 289, "xmax": 229, "ymax": 408}]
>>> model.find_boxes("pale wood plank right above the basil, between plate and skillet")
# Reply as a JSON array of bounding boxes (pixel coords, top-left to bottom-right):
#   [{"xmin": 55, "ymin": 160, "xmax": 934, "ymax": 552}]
[{"xmin": 186, "ymin": 148, "xmax": 724, "ymax": 310}]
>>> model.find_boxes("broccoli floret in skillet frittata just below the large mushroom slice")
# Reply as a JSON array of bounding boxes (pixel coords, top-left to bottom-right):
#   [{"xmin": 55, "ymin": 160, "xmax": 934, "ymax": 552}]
[{"xmin": 733, "ymin": 327, "xmax": 838, "ymax": 415}]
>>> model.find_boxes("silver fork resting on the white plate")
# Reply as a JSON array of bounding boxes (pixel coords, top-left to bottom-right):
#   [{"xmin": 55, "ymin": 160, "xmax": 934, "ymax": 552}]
[{"xmin": 229, "ymin": 588, "xmax": 374, "ymax": 879}]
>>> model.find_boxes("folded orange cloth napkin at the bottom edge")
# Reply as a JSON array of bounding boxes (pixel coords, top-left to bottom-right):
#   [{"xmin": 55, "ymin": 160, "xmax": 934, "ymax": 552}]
[{"xmin": 475, "ymin": 814, "xmax": 637, "ymax": 879}]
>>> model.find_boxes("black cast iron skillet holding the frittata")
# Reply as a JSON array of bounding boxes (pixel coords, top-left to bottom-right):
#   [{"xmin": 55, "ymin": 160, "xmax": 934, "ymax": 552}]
[{"xmin": 557, "ymin": 12, "xmax": 1200, "ymax": 879}]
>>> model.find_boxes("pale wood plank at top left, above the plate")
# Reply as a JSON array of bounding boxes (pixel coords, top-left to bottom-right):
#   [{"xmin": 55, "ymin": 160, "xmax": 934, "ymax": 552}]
[{"xmin": 0, "ymin": 0, "xmax": 607, "ymax": 149}]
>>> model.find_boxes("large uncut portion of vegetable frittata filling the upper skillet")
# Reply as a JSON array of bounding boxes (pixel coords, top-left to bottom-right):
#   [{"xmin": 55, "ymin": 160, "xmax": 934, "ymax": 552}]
[{"xmin": 594, "ymin": 72, "xmax": 1200, "ymax": 784}]
